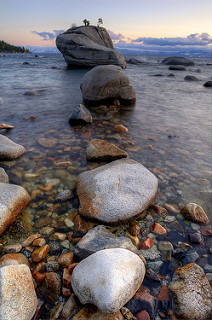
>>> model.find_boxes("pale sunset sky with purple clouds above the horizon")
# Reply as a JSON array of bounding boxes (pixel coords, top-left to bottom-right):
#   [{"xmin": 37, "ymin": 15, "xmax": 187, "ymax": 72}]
[{"xmin": 0, "ymin": 0, "xmax": 212, "ymax": 47}]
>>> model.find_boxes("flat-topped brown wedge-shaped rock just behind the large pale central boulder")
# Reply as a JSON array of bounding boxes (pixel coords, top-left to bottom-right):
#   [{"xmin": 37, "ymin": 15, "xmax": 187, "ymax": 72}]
[{"xmin": 85, "ymin": 139, "xmax": 127, "ymax": 162}]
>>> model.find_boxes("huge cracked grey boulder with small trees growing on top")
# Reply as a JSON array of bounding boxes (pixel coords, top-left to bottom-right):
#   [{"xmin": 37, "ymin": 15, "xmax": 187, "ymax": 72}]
[{"xmin": 56, "ymin": 26, "xmax": 126, "ymax": 68}]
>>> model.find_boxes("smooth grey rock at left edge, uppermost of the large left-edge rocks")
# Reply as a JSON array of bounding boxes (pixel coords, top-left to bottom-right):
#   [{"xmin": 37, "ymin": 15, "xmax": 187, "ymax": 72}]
[{"xmin": 0, "ymin": 134, "xmax": 26, "ymax": 160}]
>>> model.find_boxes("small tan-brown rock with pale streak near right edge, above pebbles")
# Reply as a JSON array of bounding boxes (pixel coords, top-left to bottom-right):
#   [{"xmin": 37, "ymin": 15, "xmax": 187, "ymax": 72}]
[{"xmin": 181, "ymin": 203, "xmax": 209, "ymax": 224}]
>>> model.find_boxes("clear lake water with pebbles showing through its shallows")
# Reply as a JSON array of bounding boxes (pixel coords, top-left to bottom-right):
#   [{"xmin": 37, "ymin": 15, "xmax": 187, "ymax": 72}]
[{"xmin": 0, "ymin": 54, "xmax": 212, "ymax": 232}]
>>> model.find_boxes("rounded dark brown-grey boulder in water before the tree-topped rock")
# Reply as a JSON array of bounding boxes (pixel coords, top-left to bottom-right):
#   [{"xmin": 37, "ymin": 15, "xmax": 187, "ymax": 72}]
[{"xmin": 80, "ymin": 65, "xmax": 136, "ymax": 104}]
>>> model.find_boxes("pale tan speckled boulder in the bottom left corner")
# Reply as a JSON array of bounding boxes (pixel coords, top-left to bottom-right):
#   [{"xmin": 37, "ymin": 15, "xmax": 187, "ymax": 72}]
[{"xmin": 0, "ymin": 264, "xmax": 37, "ymax": 320}]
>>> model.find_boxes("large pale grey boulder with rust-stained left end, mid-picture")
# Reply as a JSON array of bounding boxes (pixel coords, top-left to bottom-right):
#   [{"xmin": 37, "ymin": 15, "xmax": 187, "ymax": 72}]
[{"xmin": 77, "ymin": 159, "xmax": 158, "ymax": 223}]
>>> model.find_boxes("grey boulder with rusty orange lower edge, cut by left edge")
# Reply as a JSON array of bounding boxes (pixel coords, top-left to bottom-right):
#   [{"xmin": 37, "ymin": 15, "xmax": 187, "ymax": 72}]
[{"xmin": 0, "ymin": 183, "xmax": 30, "ymax": 235}]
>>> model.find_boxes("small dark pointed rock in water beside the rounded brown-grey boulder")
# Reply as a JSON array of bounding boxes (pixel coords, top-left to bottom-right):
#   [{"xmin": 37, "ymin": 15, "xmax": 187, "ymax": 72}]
[{"xmin": 68, "ymin": 104, "xmax": 93, "ymax": 124}]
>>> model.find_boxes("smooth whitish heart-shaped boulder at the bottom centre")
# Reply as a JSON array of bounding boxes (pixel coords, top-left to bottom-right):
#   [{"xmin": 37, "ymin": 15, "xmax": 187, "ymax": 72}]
[{"xmin": 71, "ymin": 248, "xmax": 145, "ymax": 314}]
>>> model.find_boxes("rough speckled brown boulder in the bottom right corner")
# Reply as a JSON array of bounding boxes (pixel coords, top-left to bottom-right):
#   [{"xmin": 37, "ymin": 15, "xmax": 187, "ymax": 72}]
[{"xmin": 170, "ymin": 263, "xmax": 212, "ymax": 320}]
